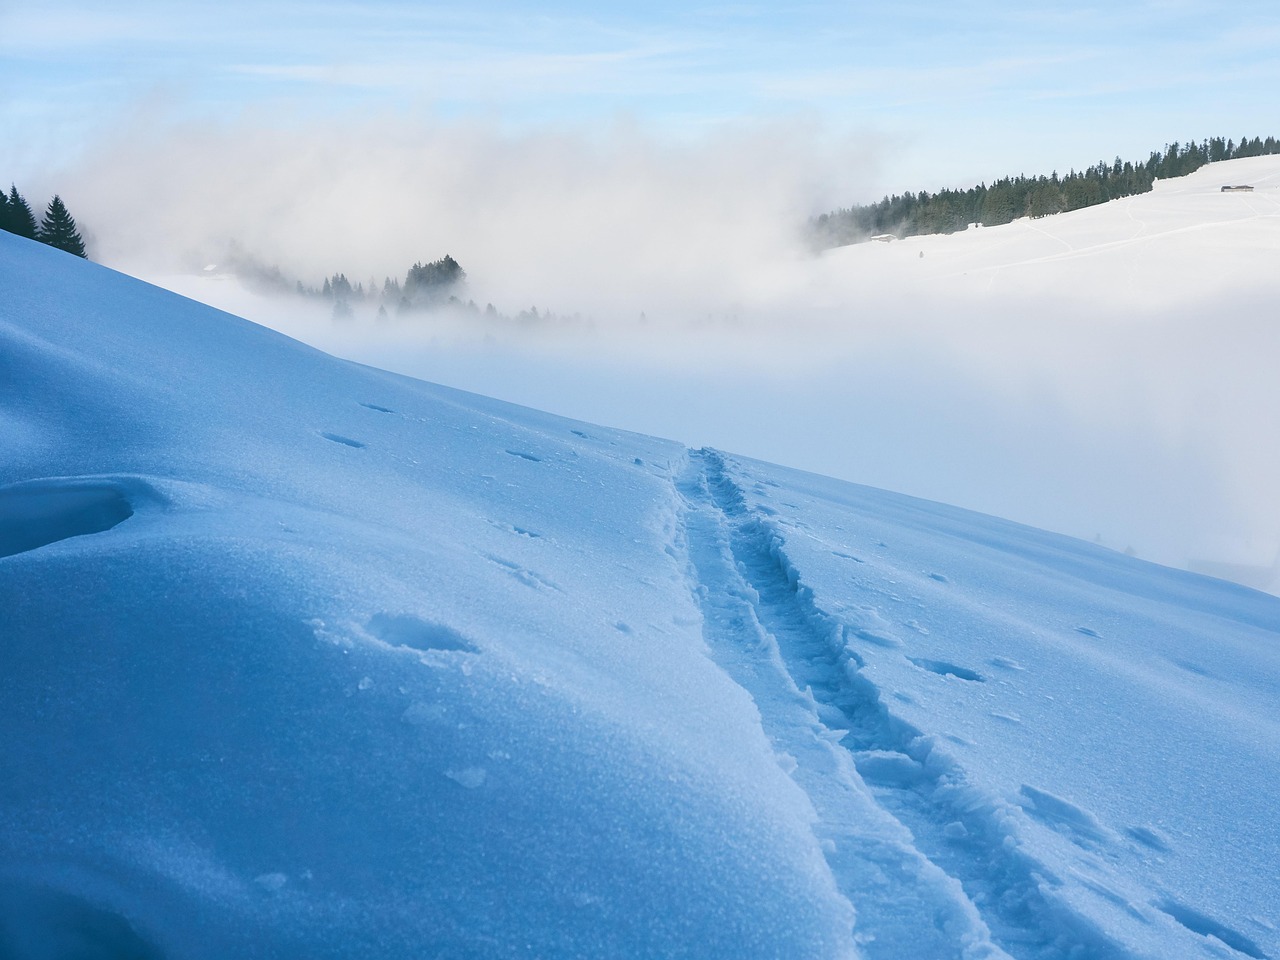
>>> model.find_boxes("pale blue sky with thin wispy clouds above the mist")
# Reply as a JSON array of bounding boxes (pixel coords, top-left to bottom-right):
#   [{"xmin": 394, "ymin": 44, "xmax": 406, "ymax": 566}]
[{"xmin": 0, "ymin": 0, "xmax": 1280, "ymax": 197}]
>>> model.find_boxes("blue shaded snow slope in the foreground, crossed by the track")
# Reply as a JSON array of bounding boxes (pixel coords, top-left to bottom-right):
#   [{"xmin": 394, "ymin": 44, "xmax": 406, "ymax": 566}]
[{"xmin": 0, "ymin": 236, "xmax": 1280, "ymax": 960}]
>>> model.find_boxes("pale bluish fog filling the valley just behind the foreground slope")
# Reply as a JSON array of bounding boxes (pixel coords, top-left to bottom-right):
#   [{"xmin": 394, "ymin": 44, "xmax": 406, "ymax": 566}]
[{"xmin": 157, "ymin": 267, "xmax": 1280, "ymax": 586}]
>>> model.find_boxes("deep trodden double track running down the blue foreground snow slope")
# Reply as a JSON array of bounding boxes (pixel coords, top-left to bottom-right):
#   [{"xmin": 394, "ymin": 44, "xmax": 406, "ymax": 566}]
[{"xmin": 677, "ymin": 449, "xmax": 1128, "ymax": 960}]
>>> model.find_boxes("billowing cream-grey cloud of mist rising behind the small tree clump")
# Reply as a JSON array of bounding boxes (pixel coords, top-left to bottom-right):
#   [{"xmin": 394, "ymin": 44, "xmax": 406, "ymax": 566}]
[{"xmin": 59, "ymin": 119, "xmax": 874, "ymax": 323}]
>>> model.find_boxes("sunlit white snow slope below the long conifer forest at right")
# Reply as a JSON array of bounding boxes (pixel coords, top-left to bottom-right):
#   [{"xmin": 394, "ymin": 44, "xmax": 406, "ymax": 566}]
[{"xmin": 823, "ymin": 156, "xmax": 1280, "ymax": 308}]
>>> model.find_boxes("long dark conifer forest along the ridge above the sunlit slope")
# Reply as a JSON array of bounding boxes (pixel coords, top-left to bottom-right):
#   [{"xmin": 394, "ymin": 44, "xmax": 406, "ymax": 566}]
[{"xmin": 809, "ymin": 137, "xmax": 1280, "ymax": 250}]
